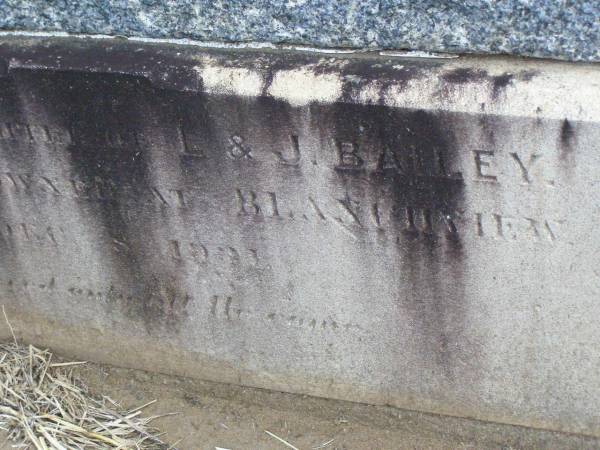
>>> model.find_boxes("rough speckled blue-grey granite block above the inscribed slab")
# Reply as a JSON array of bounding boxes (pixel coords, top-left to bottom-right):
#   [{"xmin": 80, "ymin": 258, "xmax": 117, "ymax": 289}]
[{"xmin": 0, "ymin": 0, "xmax": 600, "ymax": 61}]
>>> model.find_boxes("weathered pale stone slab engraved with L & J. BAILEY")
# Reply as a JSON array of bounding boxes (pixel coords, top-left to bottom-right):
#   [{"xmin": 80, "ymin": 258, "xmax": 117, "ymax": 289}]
[{"xmin": 0, "ymin": 38, "xmax": 600, "ymax": 435}]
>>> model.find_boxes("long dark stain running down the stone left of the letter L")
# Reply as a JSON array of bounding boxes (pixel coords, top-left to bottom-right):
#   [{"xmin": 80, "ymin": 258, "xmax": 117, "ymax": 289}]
[{"xmin": 17, "ymin": 70, "xmax": 189, "ymax": 334}]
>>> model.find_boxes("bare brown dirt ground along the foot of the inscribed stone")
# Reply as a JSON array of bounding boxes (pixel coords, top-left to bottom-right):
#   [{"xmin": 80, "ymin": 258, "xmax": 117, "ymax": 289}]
[{"xmin": 0, "ymin": 364, "xmax": 600, "ymax": 450}]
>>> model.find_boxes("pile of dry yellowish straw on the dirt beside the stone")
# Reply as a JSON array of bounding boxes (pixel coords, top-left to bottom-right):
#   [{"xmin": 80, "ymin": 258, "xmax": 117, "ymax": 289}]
[{"xmin": 0, "ymin": 308, "xmax": 171, "ymax": 450}]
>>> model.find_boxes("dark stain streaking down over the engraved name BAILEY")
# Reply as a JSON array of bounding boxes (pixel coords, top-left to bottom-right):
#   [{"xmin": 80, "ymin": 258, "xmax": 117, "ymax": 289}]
[{"xmin": 314, "ymin": 98, "xmax": 478, "ymax": 382}]
